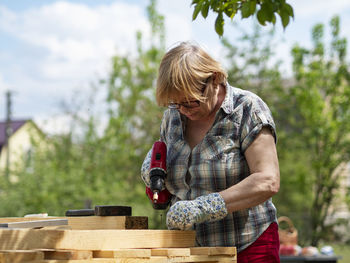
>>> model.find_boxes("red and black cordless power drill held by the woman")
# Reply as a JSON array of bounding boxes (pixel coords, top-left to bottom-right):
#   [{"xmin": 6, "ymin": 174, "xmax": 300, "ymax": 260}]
[{"xmin": 146, "ymin": 141, "xmax": 171, "ymax": 210}]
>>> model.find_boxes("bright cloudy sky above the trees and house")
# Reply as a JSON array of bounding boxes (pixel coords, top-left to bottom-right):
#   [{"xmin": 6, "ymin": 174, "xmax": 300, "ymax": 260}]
[{"xmin": 0, "ymin": 0, "xmax": 350, "ymax": 133}]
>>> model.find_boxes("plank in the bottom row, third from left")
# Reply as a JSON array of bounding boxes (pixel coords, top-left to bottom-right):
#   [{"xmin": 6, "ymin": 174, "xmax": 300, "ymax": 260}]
[{"xmin": 93, "ymin": 248, "xmax": 151, "ymax": 258}]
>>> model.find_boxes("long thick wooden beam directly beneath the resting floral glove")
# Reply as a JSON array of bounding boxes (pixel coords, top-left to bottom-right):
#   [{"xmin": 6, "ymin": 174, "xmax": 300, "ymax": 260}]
[{"xmin": 0, "ymin": 229, "xmax": 195, "ymax": 250}]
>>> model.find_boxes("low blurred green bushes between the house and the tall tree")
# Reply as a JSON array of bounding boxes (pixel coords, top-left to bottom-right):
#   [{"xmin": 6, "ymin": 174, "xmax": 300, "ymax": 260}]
[{"xmin": 0, "ymin": 87, "xmax": 125, "ymax": 216}]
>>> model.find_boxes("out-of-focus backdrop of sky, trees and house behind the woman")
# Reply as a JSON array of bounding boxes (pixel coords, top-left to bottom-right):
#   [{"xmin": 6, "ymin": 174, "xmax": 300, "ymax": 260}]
[{"xmin": 0, "ymin": 0, "xmax": 350, "ymax": 262}]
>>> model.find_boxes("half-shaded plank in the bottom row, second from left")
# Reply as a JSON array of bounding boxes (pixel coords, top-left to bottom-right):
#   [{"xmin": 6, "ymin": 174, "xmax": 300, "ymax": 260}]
[{"xmin": 38, "ymin": 249, "xmax": 93, "ymax": 260}]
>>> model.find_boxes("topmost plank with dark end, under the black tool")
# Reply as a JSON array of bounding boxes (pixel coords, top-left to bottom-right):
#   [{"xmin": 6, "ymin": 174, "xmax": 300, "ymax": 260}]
[{"xmin": 0, "ymin": 219, "xmax": 148, "ymax": 230}]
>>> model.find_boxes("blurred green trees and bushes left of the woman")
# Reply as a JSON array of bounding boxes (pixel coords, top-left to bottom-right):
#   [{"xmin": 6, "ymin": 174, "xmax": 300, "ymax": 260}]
[{"xmin": 0, "ymin": 1, "xmax": 165, "ymax": 228}]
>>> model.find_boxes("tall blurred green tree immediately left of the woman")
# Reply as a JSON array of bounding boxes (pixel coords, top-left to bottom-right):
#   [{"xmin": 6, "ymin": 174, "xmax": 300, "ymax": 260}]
[{"xmin": 105, "ymin": 0, "xmax": 165, "ymax": 227}]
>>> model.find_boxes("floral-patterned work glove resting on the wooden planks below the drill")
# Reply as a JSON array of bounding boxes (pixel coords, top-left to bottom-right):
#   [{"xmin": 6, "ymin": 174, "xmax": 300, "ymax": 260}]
[{"xmin": 166, "ymin": 193, "xmax": 227, "ymax": 230}]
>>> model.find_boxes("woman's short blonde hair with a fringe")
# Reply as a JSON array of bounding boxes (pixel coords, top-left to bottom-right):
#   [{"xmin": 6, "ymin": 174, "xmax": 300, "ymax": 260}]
[{"xmin": 156, "ymin": 42, "xmax": 227, "ymax": 106}]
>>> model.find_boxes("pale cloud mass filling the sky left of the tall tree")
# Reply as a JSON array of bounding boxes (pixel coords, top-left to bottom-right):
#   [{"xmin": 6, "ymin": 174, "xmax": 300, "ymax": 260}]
[{"xmin": 0, "ymin": 1, "xmax": 150, "ymax": 125}]
